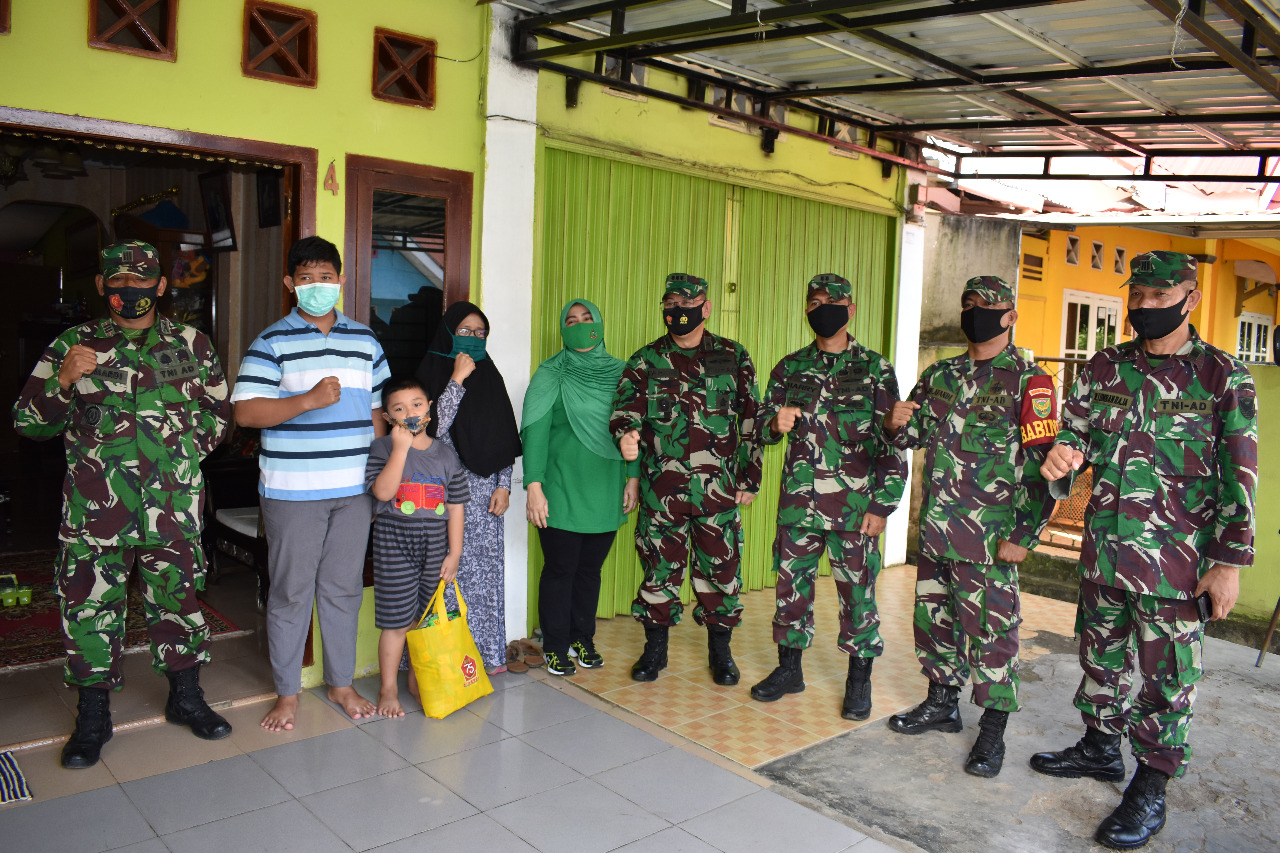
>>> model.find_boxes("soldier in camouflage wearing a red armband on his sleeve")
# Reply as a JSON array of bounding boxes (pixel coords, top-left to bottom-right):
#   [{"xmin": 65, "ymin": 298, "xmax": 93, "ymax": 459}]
[{"xmin": 884, "ymin": 275, "xmax": 1057, "ymax": 777}]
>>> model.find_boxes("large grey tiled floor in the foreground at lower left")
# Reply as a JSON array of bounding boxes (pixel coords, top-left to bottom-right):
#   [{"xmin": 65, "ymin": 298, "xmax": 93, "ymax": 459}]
[{"xmin": 0, "ymin": 672, "xmax": 893, "ymax": 853}]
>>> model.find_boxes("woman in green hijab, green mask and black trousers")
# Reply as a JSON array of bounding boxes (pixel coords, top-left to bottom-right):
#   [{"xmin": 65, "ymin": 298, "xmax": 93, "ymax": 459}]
[{"xmin": 520, "ymin": 300, "xmax": 640, "ymax": 675}]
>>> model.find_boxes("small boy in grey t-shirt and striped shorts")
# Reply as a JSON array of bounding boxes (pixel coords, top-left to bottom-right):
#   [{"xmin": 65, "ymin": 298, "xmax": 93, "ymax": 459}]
[{"xmin": 365, "ymin": 379, "xmax": 471, "ymax": 717}]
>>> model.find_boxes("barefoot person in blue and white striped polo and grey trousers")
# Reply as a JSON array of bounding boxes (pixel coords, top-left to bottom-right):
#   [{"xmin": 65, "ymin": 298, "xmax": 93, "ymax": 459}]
[{"xmin": 232, "ymin": 237, "xmax": 390, "ymax": 731}]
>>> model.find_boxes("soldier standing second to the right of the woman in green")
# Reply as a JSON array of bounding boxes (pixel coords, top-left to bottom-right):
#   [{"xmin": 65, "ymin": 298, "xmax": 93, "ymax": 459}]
[{"xmin": 751, "ymin": 273, "xmax": 906, "ymax": 720}]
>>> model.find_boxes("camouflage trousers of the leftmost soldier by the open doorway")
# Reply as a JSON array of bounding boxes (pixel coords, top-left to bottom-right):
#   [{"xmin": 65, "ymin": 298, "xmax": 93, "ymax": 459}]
[{"xmin": 58, "ymin": 539, "xmax": 210, "ymax": 689}]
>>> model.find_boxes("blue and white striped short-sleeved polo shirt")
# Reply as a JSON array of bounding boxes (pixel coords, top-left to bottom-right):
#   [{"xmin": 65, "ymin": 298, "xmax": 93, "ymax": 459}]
[{"xmin": 232, "ymin": 309, "xmax": 390, "ymax": 501}]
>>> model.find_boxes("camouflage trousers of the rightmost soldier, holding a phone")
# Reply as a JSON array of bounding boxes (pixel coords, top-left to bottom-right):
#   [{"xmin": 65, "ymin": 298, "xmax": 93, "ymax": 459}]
[{"xmin": 1075, "ymin": 580, "xmax": 1204, "ymax": 776}]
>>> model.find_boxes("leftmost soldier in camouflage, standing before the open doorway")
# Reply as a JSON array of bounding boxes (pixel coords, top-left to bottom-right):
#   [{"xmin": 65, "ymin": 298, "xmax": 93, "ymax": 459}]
[{"xmin": 14, "ymin": 241, "xmax": 232, "ymax": 767}]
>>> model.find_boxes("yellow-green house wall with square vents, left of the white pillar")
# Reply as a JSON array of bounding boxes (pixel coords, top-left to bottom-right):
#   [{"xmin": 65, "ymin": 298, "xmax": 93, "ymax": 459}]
[{"xmin": 0, "ymin": 0, "xmax": 489, "ymax": 686}]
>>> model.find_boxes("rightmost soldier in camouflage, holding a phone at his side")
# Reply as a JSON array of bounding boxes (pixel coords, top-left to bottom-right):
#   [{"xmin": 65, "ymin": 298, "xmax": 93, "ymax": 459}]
[{"xmin": 1032, "ymin": 251, "xmax": 1258, "ymax": 849}]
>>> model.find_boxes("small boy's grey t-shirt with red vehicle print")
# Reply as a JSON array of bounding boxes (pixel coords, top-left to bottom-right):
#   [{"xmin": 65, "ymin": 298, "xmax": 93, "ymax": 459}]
[{"xmin": 365, "ymin": 435, "xmax": 471, "ymax": 521}]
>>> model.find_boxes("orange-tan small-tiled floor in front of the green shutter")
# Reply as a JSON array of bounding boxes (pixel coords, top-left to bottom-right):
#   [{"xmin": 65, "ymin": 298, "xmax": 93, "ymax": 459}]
[{"xmin": 570, "ymin": 566, "xmax": 1075, "ymax": 767}]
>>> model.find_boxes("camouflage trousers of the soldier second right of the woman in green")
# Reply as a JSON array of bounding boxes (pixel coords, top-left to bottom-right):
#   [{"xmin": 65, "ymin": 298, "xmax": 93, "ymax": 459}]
[{"xmin": 773, "ymin": 525, "xmax": 884, "ymax": 657}]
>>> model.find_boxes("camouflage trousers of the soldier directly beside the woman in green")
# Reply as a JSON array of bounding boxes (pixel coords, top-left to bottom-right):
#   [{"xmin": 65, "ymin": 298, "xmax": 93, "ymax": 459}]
[{"xmin": 631, "ymin": 507, "xmax": 742, "ymax": 628}]
